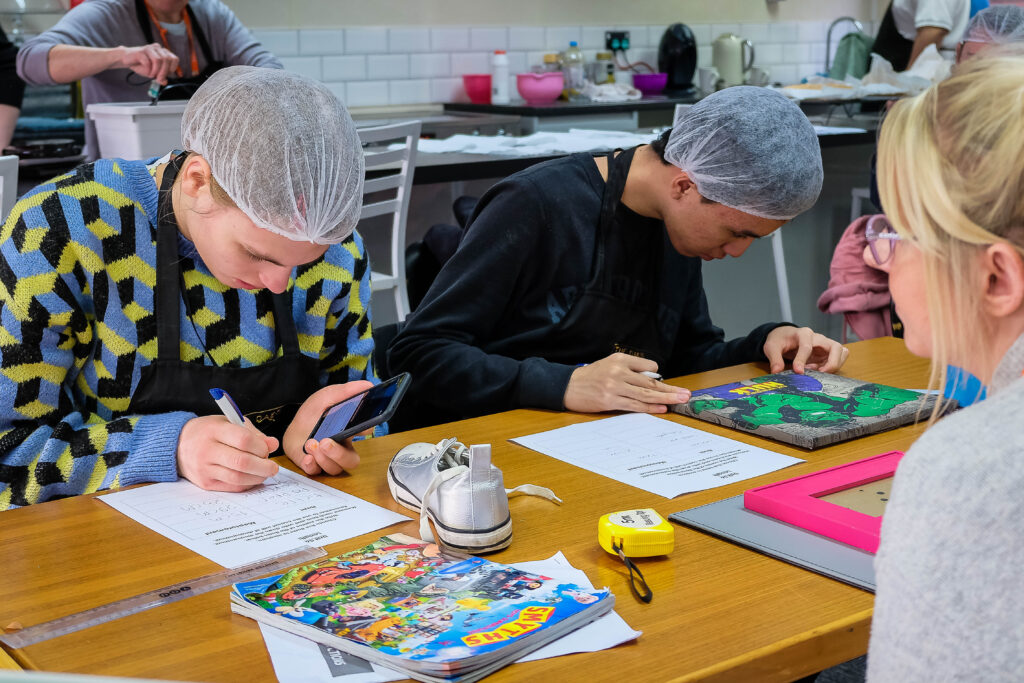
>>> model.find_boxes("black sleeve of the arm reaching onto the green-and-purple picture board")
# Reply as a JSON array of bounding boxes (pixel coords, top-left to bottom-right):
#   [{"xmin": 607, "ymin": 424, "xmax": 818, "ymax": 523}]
[{"xmin": 662, "ymin": 267, "xmax": 791, "ymax": 377}]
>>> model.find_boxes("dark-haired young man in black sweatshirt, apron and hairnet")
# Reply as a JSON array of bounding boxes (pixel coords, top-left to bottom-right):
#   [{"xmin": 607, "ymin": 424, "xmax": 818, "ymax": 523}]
[{"xmin": 387, "ymin": 86, "xmax": 847, "ymax": 428}]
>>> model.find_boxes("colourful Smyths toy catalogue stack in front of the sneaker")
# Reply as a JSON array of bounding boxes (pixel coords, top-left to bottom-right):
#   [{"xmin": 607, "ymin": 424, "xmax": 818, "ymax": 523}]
[{"xmin": 231, "ymin": 535, "xmax": 614, "ymax": 682}]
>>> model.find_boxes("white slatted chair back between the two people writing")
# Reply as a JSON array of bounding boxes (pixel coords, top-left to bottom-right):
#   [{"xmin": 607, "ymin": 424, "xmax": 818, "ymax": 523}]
[{"xmin": 357, "ymin": 121, "xmax": 422, "ymax": 321}]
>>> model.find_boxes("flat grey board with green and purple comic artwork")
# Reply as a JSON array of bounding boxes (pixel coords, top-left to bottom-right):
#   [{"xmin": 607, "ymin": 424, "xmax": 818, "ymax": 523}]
[{"xmin": 672, "ymin": 370, "xmax": 952, "ymax": 449}]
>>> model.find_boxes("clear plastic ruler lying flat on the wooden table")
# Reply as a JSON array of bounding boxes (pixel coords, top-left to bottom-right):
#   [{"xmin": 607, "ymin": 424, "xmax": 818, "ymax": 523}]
[{"xmin": 0, "ymin": 548, "xmax": 327, "ymax": 647}]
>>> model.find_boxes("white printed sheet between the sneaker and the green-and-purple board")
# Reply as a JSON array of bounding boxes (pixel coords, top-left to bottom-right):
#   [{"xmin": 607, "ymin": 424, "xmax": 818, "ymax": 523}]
[{"xmin": 512, "ymin": 413, "xmax": 804, "ymax": 498}]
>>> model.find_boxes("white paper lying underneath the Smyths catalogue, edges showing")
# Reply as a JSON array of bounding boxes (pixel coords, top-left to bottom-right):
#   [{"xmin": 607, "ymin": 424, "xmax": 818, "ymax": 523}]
[{"xmin": 259, "ymin": 552, "xmax": 641, "ymax": 683}]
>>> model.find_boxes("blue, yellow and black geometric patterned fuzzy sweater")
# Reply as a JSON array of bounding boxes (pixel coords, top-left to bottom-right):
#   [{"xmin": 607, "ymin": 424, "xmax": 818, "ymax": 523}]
[{"xmin": 0, "ymin": 160, "xmax": 377, "ymax": 510}]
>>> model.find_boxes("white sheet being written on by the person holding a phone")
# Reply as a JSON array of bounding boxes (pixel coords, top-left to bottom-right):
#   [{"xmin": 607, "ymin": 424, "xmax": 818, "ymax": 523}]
[{"xmin": 99, "ymin": 469, "xmax": 409, "ymax": 568}]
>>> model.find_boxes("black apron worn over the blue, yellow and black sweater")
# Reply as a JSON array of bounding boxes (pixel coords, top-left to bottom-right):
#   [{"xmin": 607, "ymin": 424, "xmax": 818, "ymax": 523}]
[{"xmin": 128, "ymin": 155, "xmax": 319, "ymax": 439}]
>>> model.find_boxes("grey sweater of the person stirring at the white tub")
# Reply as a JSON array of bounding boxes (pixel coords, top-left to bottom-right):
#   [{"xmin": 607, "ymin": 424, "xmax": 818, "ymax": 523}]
[{"xmin": 17, "ymin": 0, "xmax": 283, "ymax": 159}]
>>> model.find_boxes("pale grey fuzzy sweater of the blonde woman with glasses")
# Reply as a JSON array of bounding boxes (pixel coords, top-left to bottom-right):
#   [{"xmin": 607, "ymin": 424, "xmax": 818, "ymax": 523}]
[{"xmin": 867, "ymin": 337, "xmax": 1024, "ymax": 683}]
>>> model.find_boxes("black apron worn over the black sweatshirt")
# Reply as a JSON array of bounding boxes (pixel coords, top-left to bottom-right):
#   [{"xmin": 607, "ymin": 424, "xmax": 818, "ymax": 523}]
[{"xmin": 497, "ymin": 148, "xmax": 672, "ymax": 368}]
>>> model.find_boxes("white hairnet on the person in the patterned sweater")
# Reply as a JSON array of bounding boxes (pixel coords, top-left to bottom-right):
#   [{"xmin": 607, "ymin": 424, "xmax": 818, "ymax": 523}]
[{"xmin": 181, "ymin": 67, "xmax": 364, "ymax": 244}]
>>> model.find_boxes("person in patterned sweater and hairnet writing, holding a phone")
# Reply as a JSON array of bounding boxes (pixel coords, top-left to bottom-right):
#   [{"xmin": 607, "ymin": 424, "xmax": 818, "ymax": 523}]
[{"xmin": 0, "ymin": 67, "xmax": 377, "ymax": 510}]
